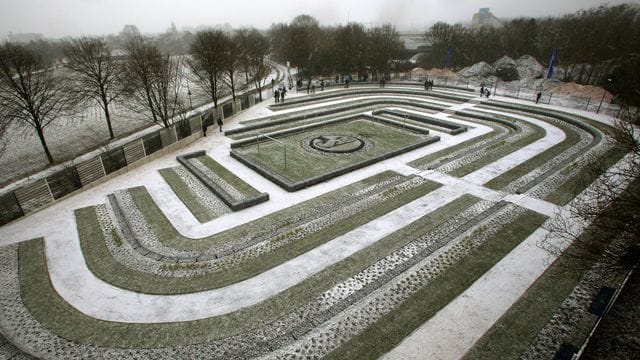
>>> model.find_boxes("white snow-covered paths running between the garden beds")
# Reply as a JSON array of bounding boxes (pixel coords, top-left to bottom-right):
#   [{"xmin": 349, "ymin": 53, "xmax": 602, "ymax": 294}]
[{"xmin": 0, "ymin": 84, "xmax": 624, "ymax": 359}]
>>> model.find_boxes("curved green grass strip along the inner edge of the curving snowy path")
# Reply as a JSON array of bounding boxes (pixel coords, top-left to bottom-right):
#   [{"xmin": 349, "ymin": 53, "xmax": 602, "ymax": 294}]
[{"xmin": 85, "ymin": 182, "xmax": 440, "ymax": 295}]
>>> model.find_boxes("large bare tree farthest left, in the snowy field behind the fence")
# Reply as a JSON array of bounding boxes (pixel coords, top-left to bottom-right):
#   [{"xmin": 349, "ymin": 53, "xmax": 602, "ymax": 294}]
[{"xmin": 0, "ymin": 43, "xmax": 76, "ymax": 163}]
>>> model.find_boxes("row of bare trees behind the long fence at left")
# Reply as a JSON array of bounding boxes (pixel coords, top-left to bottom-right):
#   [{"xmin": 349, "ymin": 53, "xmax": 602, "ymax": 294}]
[{"xmin": 0, "ymin": 29, "xmax": 270, "ymax": 163}]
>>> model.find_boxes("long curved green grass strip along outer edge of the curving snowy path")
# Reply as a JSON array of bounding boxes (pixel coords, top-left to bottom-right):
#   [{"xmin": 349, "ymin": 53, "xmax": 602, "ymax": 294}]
[{"xmin": 19, "ymin": 195, "xmax": 478, "ymax": 348}]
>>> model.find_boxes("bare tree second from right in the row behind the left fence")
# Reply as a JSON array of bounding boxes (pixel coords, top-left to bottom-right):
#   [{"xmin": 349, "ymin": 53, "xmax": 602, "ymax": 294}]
[{"xmin": 187, "ymin": 30, "xmax": 225, "ymax": 107}]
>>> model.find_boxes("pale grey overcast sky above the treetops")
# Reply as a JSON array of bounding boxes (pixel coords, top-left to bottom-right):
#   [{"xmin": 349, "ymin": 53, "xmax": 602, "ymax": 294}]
[{"xmin": 0, "ymin": 0, "xmax": 640, "ymax": 38}]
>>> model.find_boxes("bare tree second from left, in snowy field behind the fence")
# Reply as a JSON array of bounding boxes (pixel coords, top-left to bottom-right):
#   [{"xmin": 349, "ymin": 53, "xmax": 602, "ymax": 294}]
[{"xmin": 64, "ymin": 37, "xmax": 121, "ymax": 139}]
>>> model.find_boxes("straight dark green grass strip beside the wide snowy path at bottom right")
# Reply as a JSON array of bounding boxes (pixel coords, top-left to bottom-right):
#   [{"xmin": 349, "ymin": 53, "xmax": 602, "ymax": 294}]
[{"xmin": 327, "ymin": 210, "xmax": 546, "ymax": 359}]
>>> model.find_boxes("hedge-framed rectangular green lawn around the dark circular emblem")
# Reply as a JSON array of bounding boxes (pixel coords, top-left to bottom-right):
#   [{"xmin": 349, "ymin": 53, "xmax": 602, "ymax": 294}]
[{"xmin": 235, "ymin": 119, "xmax": 426, "ymax": 183}]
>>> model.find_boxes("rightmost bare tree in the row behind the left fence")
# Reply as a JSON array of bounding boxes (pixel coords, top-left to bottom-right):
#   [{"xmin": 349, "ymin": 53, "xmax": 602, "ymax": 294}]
[{"xmin": 235, "ymin": 29, "xmax": 270, "ymax": 101}]
